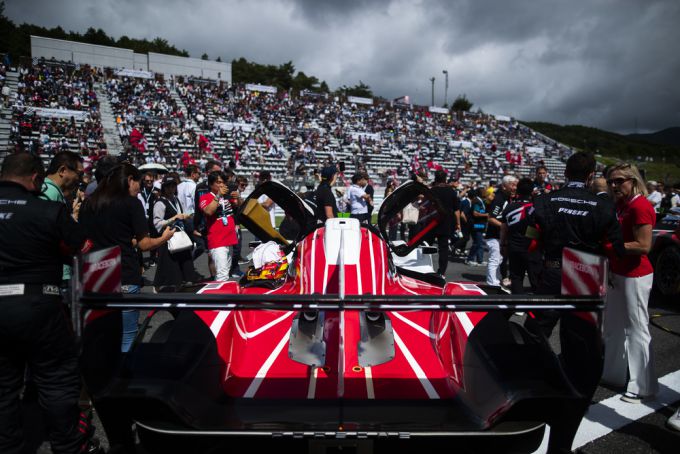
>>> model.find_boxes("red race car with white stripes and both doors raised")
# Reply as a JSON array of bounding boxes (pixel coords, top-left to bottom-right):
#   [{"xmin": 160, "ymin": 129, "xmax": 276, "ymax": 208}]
[{"xmin": 73, "ymin": 181, "xmax": 606, "ymax": 453}]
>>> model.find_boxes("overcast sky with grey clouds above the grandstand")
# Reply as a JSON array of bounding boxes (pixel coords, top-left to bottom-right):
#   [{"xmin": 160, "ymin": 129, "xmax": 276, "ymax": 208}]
[{"xmin": 5, "ymin": 0, "xmax": 680, "ymax": 133}]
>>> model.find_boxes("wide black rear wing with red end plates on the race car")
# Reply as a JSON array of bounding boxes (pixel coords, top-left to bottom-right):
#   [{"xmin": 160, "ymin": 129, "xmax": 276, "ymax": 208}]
[{"xmin": 71, "ymin": 247, "xmax": 608, "ymax": 330}]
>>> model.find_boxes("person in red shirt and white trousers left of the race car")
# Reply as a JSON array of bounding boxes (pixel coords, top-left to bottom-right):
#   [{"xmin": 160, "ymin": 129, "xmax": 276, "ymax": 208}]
[{"xmin": 199, "ymin": 172, "xmax": 238, "ymax": 281}]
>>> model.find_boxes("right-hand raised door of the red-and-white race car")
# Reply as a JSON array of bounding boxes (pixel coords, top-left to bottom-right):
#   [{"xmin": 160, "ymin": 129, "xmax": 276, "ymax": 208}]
[{"xmin": 378, "ymin": 181, "xmax": 445, "ymax": 257}]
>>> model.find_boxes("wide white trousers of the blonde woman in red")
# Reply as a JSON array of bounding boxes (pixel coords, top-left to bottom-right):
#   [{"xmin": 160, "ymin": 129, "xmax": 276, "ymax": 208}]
[{"xmin": 602, "ymin": 274, "xmax": 658, "ymax": 396}]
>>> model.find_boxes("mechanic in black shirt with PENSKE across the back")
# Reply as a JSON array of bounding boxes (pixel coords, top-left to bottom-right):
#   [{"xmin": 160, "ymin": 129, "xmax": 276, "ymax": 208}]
[{"xmin": 525, "ymin": 152, "xmax": 625, "ymax": 453}]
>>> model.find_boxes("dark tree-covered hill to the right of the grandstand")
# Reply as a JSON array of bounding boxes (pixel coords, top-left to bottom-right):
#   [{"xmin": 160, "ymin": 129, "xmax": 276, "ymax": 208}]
[{"xmin": 522, "ymin": 121, "xmax": 680, "ymax": 183}]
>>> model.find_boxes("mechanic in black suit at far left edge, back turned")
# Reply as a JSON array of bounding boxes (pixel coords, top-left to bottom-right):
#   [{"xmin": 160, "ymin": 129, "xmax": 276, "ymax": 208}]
[{"xmin": 0, "ymin": 153, "xmax": 91, "ymax": 454}]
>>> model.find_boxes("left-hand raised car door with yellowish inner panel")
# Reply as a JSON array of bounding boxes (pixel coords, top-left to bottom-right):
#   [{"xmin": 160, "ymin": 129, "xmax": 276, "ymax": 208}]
[{"xmin": 237, "ymin": 180, "xmax": 316, "ymax": 248}]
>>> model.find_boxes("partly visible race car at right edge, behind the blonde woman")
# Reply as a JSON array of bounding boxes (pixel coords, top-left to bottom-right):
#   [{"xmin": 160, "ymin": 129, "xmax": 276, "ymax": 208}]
[{"xmin": 649, "ymin": 207, "xmax": 680, "ymax": 296}]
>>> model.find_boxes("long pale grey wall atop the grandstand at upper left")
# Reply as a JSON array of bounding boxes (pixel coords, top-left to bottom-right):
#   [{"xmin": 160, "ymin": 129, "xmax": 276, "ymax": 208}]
[{"xmin": 31, "ymin": 35, "xmax": 231, "ymax": 83}]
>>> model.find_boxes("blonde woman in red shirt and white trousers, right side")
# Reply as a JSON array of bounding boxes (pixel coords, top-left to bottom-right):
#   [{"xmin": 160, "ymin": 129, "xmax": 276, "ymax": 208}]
[{"xmin": 602, "ymin": 164, "xmax": 658, "ymax": 403}]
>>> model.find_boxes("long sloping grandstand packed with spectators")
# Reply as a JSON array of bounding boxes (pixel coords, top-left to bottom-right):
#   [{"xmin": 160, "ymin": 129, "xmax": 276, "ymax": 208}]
[{"xmin": 0, "ymin": 55, "xmax": 571, "ymax": 197}]
